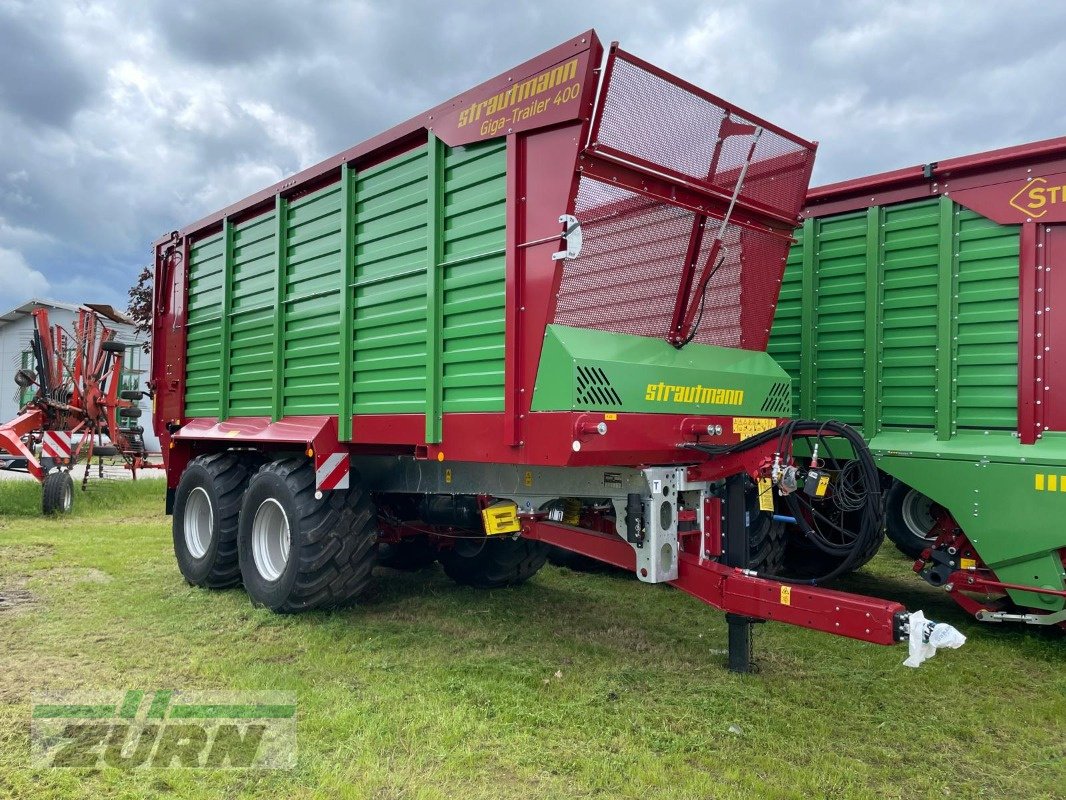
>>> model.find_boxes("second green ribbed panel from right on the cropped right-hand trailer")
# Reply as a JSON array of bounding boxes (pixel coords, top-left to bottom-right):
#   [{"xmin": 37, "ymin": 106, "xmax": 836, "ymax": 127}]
[{"xmin": 879, "ymin": 199, "xmax": 940, "ymax": 428}]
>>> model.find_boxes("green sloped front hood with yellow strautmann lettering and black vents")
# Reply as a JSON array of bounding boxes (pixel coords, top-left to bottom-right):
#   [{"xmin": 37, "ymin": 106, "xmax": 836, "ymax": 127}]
[{"xmin": 533, "ymin": 325, "xmax": 791, "ymax": 417}]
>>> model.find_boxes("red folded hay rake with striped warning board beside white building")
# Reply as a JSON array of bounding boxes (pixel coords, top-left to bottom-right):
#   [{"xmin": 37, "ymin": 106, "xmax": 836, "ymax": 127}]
[{"xmin": 0, "ymin": 308, "xmax": 162, "ymax": 514}]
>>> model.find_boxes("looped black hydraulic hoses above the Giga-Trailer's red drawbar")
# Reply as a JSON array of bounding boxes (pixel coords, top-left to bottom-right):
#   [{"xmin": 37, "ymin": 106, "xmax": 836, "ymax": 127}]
[{"xmin": 689, "ymin": 419, "xmax": 884, "ymax": 586}]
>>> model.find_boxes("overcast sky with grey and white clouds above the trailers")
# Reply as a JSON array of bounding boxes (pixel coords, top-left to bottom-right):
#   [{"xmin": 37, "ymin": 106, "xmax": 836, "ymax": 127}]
[{"xmin": 0, "ymin": 0, "xmax": 1066, "ymax": 311}]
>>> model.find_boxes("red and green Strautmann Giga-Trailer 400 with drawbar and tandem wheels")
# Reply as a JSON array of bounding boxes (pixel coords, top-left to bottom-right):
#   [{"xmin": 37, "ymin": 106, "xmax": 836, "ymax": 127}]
[{"xmin": 150, "ymin": 31, "xmax": 925, "ymax": 668}]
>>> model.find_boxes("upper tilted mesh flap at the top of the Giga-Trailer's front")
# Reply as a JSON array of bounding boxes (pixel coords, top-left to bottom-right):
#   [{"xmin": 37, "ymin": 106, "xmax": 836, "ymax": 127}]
[{"xmin": 594, "ymin": 52, "xmax": 814, "ymax": 222}]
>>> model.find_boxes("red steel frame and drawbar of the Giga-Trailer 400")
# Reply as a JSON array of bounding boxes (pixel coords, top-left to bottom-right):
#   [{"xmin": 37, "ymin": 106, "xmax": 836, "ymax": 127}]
[{"xmin": 150, "ymin": 31, "xmax": 905, "ymax": 644}]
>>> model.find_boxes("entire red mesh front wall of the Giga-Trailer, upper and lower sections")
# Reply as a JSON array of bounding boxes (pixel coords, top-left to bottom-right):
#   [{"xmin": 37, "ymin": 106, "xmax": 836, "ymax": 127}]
[{"xmin": 554, "ymin": 49, "xmax": 813, "ymax": 350}]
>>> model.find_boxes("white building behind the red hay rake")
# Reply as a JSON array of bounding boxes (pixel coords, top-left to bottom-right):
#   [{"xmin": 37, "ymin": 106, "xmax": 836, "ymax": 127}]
[{"xmin": 0, "ymin": 300, "xmax": 159, "ymax": 452}]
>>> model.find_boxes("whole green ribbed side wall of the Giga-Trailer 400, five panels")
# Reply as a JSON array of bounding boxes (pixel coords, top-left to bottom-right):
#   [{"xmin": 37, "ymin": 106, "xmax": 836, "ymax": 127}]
[{"xmin": 185, "ymin": 141, "xmax": 506, "ymax": 426}]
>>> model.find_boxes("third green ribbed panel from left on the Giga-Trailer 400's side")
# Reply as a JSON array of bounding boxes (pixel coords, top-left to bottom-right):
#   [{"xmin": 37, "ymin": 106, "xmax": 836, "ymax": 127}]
[{"xmin": 281, "ymin": 183, "xmax": 342, "ymax": 415}]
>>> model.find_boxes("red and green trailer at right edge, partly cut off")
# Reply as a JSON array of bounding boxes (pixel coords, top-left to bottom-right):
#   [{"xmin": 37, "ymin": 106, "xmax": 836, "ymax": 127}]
[{"xmin": 770, "ymin": 138, "xmax": 1066, "ymax": 626}]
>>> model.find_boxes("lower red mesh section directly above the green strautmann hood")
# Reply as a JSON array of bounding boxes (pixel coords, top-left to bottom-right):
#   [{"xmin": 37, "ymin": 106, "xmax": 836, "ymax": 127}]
[{"xmin": 554, "ymin": 177, "xmax": 788, "ymax": 350}]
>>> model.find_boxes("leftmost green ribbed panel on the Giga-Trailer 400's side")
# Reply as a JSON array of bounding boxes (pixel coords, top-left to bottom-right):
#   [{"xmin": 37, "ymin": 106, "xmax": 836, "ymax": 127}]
[{"xmin": 185, "ymin": 233, "xmax": 225, "ymax": 417}]
